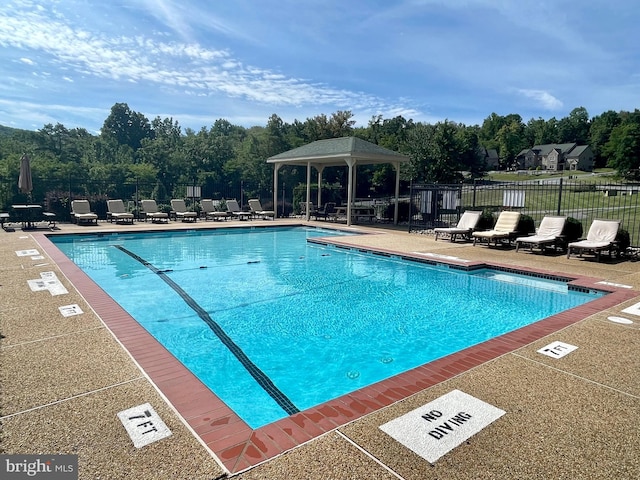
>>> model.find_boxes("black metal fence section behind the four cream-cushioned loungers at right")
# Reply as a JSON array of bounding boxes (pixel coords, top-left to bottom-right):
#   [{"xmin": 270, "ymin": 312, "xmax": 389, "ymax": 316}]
[{"xmin": 408, "ymin": 177, "xmax": 640, "ymax": 246}]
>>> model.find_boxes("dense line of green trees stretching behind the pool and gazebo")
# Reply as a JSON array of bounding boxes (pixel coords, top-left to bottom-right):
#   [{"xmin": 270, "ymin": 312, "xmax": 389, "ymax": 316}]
[{"xmin": 0, "ymin": 103, "xmax": 640, "ymax": 209}]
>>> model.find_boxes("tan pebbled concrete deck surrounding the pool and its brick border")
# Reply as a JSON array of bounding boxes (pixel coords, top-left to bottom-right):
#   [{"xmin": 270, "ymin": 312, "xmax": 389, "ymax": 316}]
[{"xmin": 0, "ymin": 219, "xmax": 640, "ymax": 479}]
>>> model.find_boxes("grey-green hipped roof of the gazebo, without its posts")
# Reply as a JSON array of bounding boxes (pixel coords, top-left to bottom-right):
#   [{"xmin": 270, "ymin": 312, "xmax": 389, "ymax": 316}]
[{"xmin": 267, "ymin": 137, "xmax": 409, "ymax": 166}]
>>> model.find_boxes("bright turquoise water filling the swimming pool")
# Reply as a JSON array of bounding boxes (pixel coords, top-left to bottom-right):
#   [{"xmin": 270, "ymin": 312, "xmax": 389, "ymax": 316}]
[{"xmin": 50, "ymin": 227, "xmax": 600, "ymax": 428}]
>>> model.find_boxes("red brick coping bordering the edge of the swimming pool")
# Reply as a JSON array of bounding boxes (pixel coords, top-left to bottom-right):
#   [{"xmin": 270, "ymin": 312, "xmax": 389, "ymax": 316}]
[{"xmin": 33, "ymin": 233, "xmax": 638, "ymax": 473}]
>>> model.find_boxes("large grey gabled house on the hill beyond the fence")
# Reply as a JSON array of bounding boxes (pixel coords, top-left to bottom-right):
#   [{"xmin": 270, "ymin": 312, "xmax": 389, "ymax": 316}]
[{"xmin": 516, "ymin": 143, "xmax": 594, "ymax": 172}]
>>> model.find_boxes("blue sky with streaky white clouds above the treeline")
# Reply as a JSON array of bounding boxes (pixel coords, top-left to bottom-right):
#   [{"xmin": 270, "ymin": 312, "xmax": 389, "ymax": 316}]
[{"xmin": 0, "ymin": 0, "xmax": 640, "ymax": 134}]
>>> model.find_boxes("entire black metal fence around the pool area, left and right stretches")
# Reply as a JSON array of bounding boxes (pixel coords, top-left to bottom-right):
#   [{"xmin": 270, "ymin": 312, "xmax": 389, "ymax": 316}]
[{"xmin": 5, "ymin": 177, "xmax": 640, "ymax": 246}]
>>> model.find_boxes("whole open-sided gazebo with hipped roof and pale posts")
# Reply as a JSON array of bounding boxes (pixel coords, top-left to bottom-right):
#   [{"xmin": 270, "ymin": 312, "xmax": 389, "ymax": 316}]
[{"xmin": 267, "ymin": 137, "xmax": 409, "ymax": 225}]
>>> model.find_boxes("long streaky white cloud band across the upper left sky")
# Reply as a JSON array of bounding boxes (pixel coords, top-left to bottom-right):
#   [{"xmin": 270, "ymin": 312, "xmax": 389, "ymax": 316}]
[{"xmin": 0, "ymin": 2, "xmax": 416, "ymax": 118}]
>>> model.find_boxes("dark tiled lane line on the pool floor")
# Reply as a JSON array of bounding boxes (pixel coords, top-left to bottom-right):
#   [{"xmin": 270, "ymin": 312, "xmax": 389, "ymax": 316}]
[{"xmin": 114, "ymin": 245, "xmax": 300, "ymax": 415}]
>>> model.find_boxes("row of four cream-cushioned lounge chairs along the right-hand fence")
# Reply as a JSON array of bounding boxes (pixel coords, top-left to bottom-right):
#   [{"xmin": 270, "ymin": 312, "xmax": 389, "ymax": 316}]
[{"xmin": 434, "ymin": 210, "xmax": 620, "ymax": 261}]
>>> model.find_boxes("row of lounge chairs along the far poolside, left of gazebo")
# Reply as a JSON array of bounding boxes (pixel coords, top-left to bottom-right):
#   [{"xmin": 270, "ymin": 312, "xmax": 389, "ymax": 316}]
[{"xmin": 71, "ymin": 199, "xmax": 275, "ymax": 225}]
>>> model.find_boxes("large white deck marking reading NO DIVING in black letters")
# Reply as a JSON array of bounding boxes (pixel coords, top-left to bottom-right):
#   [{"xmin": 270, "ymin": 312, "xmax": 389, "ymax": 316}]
[{"xmin": 380, "ymin": 390, "xmax": 505, "ymax": 463}]
